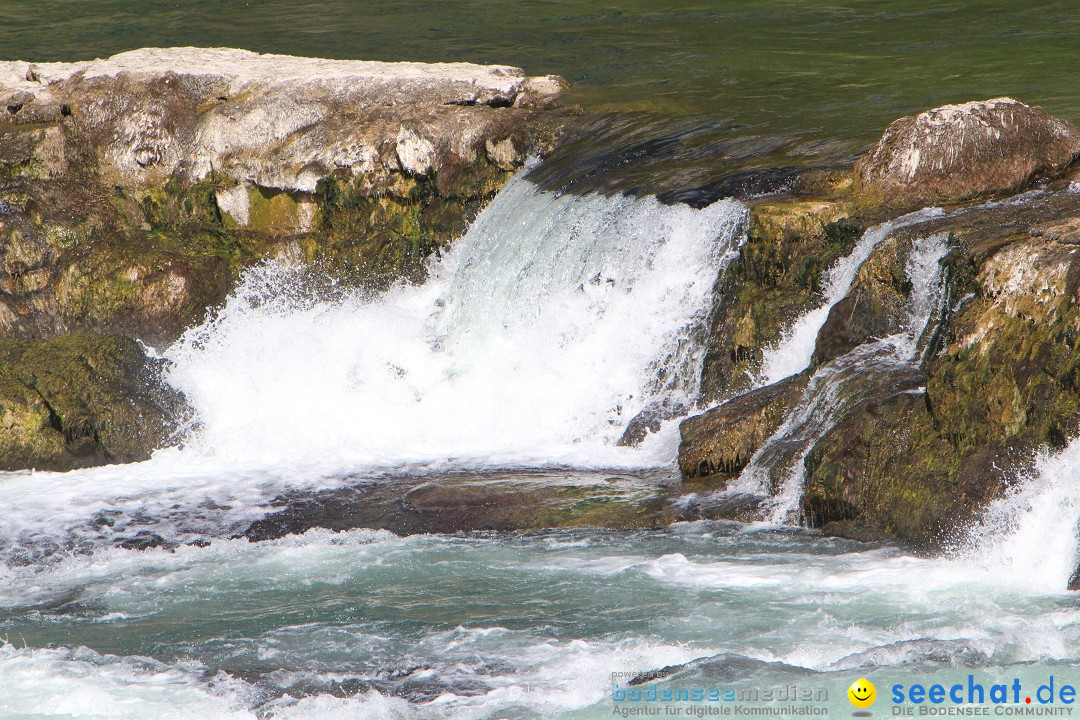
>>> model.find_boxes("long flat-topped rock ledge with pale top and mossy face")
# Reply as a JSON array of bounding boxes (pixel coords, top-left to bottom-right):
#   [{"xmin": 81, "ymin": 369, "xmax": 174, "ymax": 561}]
[{"xmin": 0, "ymin": 47, "xmax": 565, "ymax": 347}]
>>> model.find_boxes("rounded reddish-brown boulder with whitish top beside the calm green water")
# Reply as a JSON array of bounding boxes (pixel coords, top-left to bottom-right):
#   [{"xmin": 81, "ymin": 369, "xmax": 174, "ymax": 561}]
[{"xmin": 855, "ymin": 97, "xmax": 1080, "ymax": 206}]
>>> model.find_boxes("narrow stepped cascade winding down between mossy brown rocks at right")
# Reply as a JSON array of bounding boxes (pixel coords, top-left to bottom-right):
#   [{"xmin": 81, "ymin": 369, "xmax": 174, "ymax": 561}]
[{"xmin": 727, "ymin": 235, "xmax": 948, "ymax": 524}]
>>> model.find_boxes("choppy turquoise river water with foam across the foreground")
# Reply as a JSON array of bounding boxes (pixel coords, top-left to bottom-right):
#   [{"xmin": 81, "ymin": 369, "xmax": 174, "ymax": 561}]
[{"xmin": 0, "ymin": 522, "xmax": 1080, "ymax": 719}]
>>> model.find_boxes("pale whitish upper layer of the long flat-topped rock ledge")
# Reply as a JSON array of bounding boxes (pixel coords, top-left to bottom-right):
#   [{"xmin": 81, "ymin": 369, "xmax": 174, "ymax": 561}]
[{"xmin": 0, "ymin": 47, "xmax": 566, "ymax": 194}]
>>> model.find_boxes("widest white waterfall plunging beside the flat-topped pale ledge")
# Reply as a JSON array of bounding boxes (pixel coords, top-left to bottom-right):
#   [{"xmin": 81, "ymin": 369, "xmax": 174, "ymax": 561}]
[{"xmin": 166, "ymin": 178, "xmax": 746, "ymax": 471}]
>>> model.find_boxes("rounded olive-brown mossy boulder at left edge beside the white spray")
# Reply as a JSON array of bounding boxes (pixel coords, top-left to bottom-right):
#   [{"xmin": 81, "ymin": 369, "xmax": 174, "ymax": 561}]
[{"xmin": 0, "ymin": 336, "xmax": 184, "ymax": 471}]
